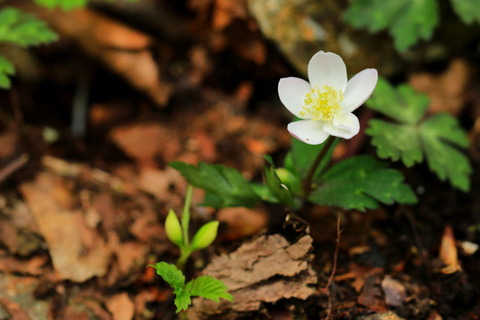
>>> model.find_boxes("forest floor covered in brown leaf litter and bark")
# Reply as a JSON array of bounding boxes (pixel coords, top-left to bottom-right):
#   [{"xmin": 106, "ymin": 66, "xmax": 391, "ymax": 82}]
[{"xmin": 0, "ymin": 1, "xmax": 480, "ymax": 320}]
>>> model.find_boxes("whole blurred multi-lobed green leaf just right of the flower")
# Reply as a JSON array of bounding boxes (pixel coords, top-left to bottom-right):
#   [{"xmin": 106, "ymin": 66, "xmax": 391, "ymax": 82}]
[{"xmin": 366, "ymin": 79, "xmax": 472, "ymax": 191}]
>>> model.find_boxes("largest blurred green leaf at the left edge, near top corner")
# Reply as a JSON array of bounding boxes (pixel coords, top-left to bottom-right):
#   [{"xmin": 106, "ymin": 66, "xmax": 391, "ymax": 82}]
[{"xmin": 0, "ymin": 8, "xmax": 58, "ymax": 47}]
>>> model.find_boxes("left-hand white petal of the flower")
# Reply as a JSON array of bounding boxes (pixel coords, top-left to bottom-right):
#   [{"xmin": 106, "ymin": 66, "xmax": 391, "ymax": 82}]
[{"xmin": 278, "ymin": 77, "xmax": 312, "ymax": 118}]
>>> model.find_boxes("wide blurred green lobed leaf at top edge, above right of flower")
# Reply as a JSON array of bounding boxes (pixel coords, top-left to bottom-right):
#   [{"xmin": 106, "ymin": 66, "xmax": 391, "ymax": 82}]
[{"xmin": 344, "ymin": 0, "xmax": 438, "ymax": 51}]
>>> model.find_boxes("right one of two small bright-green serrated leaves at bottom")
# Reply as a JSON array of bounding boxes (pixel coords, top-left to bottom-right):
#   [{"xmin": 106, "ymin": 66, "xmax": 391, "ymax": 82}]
[{"xmin": 185, "ymin": 276, "xmax": 233, "ymax": 302}]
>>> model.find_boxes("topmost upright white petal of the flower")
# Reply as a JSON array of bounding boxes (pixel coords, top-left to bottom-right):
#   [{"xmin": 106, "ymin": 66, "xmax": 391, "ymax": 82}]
[{"xmin": 308, "ymin": 51, "xmax": 347, "ymax": 92}]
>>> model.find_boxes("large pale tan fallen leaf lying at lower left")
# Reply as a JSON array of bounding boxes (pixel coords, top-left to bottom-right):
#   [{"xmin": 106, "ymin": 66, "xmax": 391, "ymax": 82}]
[{"xmin": 20, "ymin": 172, "xmax": 111, "ymax": 282}]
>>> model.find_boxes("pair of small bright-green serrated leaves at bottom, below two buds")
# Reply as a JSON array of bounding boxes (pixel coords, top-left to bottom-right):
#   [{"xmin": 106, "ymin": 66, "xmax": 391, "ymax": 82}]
[{"xmin": 148, "ymin": 262, "xmax": 233, "ymax": 313}]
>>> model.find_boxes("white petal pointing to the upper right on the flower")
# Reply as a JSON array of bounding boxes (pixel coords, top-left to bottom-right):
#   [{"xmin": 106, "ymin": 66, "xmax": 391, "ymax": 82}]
[{"xmin": 341, "ymin": 69, "xmax": 378, "ymax": 112}]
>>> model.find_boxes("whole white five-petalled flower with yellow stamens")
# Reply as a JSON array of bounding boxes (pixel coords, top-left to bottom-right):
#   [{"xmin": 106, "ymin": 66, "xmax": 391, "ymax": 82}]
[{"xmin": 278, "ymin": 51, "xmax": 378, "ymax": 144}]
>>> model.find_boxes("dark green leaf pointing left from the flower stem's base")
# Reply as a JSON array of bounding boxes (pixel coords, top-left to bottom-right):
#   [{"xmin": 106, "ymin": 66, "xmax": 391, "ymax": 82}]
[{"xmin": 170, "ymin": 161, "xmax": 260, "ymax": 208}]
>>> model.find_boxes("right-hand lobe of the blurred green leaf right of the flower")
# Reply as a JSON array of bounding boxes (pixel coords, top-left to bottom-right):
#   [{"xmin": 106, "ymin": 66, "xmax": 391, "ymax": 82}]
[{"xmin": 419, "ymin": 114, "xmax": 472, "ymax": 192}]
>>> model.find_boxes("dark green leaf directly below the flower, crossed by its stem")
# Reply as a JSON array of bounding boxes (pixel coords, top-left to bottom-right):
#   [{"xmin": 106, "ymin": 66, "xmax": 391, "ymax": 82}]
[{"xmin": 284, "ymin": 139, "xmax": 339, "ymax": 181}]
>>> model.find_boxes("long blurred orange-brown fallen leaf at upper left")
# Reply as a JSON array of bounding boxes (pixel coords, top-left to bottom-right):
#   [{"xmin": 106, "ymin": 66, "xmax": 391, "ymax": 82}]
[{"xmin": 30, "ymin": 7, "xmax": 171, "ymax": 106}]
